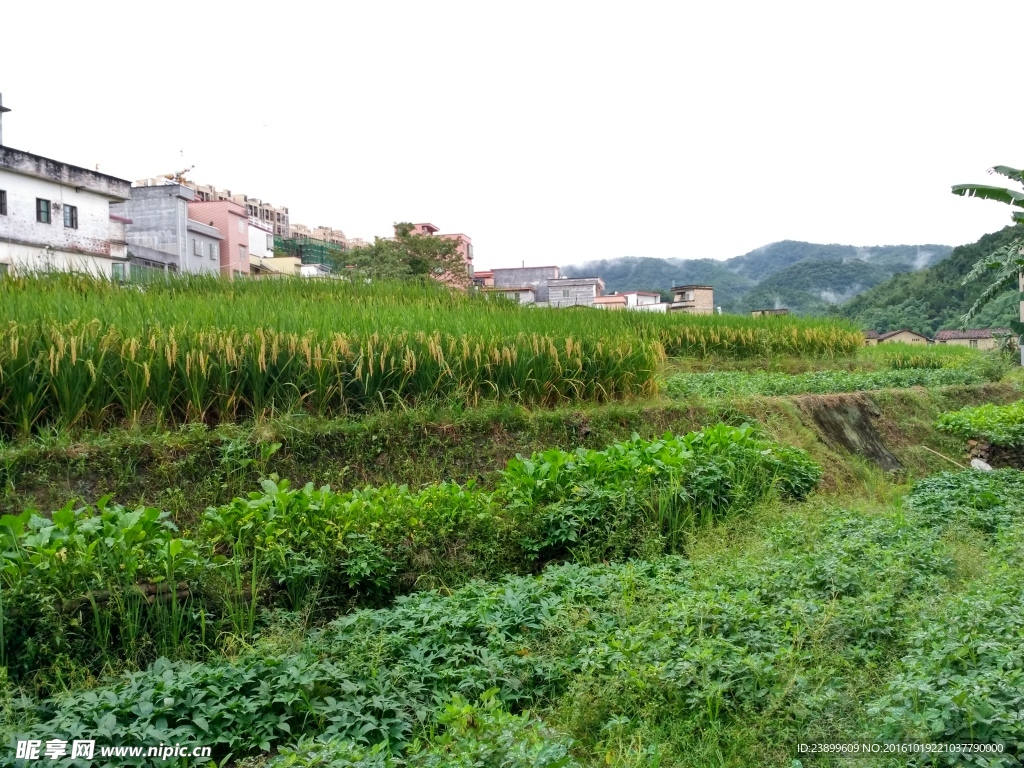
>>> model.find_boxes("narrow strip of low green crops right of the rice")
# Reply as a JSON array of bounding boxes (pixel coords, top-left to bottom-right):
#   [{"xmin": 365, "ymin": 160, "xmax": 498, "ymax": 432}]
[{"xmin": 665, "ymin": 366, "xmax": 998, "ymax": 397}]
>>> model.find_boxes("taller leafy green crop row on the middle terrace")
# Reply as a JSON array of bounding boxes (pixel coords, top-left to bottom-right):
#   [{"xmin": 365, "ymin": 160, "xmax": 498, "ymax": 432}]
[{"xmin": 0, "ymin": 425, "xmax": 821, "ymax": 679}]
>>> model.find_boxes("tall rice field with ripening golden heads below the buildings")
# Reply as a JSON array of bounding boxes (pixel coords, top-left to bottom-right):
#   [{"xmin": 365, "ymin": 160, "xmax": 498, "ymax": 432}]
[{"xmin": 0, "ymin": 274, "xmax": 861, "ymax": 436}]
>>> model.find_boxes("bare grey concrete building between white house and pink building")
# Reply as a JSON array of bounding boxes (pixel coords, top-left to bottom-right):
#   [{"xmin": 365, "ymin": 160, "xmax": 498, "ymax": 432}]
[{"xmin": 111, "ymin": 184, "xmax": 223, "ymax": 274}]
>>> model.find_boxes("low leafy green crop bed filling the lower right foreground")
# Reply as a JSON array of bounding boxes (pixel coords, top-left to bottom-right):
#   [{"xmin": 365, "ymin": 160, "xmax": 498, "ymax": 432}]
[{"xmin": 8, "ymin": 472, "xmax": 1024, "ymax": 768}]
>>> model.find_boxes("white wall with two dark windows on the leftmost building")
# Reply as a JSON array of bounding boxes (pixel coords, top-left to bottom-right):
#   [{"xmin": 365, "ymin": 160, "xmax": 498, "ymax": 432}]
[{"xmin": 0, "ymin": 169, "xmax": 118, "ymax": 275}]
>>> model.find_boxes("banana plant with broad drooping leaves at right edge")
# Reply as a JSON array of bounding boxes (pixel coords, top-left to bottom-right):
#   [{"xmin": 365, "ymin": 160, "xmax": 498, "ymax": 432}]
[{"xmin": 952, "ymin": 165, "xmax": 1024, "ymax": 337}]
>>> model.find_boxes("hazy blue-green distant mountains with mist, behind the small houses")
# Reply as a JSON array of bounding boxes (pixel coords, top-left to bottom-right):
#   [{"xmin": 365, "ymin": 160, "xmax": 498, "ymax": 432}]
[{"xmin": 562, "ymin": 240, "xmax": 952, "ymax": 314}]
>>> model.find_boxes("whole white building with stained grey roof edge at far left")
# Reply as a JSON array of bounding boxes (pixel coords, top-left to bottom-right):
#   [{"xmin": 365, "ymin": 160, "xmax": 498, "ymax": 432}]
[{"xmin": 0, "ymin": 143, "xmax": 131, "ymax": 278}]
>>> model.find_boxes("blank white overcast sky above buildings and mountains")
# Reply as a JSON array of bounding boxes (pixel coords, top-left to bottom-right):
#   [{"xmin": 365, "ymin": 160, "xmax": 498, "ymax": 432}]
[{"xmin": 0, "ymin": 0, "xmax": 1024, "ymax": 269}]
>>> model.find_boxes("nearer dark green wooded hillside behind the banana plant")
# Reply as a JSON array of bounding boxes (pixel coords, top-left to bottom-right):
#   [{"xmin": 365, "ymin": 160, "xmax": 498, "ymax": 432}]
[{"xmin": 840, "ymin": 225, "xmax": 1024, "ymax": 335}]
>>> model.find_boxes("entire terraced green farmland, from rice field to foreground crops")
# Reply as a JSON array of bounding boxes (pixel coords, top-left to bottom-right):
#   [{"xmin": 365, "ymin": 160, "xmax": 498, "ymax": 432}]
[{"xmin": 0, "ymin": 276, "xmax": 1024, "ymax": 768}]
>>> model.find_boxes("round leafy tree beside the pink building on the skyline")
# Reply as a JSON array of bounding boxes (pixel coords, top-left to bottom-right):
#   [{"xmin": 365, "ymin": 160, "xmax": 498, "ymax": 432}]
[{"xmin": 345, "ymin": 221, "xmax": 469, "ymax": 286}]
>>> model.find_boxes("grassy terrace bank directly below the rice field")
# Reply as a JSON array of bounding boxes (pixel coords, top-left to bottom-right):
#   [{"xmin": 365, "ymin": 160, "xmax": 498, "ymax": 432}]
[{"xmin": 6, "ymin": 382, "xmax": 1020, "ymax": 518}]
